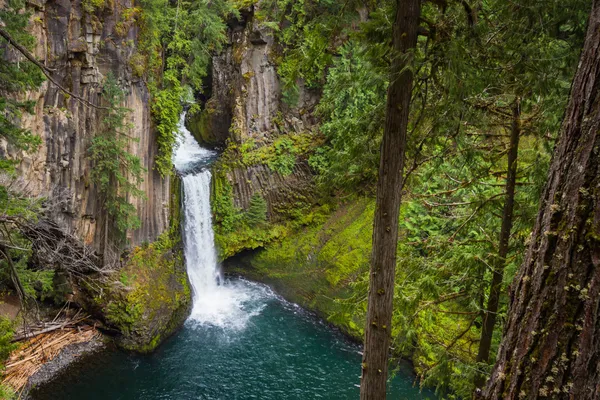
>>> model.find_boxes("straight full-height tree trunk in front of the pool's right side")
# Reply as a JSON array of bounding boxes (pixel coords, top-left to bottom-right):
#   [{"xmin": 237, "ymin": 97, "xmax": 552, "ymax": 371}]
[{"xmin": 360, "ymin": 0, "xmax": 420, "ymax": 400}]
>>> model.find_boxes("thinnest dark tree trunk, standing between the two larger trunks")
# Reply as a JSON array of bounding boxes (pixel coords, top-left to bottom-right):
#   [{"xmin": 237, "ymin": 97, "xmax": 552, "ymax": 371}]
[{"xmin": 476, "ymin": 98, "xmax": 521, "ymax": 378}]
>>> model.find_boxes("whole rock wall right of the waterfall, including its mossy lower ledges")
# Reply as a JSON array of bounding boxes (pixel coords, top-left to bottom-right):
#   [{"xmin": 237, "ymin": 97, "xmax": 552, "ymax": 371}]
[{"xmin": 187, "ymin": 2, "xmax": 320, "ymax": 258}]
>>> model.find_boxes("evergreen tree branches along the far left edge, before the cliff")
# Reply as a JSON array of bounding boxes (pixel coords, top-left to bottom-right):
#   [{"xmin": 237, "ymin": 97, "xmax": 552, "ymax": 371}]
[{"xmin": 0, "ymin": 0, "xmax": 43, "ymax": 304}]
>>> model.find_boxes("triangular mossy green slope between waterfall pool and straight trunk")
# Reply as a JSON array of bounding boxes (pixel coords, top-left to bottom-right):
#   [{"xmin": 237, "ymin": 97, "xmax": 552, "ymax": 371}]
[{"xmin": 227, "ymin": 199, "xmax": 374, "ymax": 339}]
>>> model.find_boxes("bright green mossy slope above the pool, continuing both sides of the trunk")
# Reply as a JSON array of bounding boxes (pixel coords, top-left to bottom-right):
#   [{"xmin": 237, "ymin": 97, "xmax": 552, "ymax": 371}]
[{"xmin": 230, "ymin": 198, "xmax": 486, "ymax": 396}]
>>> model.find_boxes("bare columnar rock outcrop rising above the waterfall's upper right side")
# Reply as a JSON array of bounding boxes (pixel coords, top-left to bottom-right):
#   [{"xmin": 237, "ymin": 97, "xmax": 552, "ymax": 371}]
[{"xmin": 188, "ymin": 2, "xmax": 319, "ymax": 145}]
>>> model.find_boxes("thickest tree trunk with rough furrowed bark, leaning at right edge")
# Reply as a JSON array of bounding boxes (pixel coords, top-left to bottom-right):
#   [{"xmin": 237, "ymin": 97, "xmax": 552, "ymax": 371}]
[{"xmin": 483, "ymin": 0, "xmax": 600, "ymax": 400}]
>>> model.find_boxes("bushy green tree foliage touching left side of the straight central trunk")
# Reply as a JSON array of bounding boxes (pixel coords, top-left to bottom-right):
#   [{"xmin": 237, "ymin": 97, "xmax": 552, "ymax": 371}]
[{"xmin": 310, "ymin": 41, "xmax": 387, "ymax": 188}]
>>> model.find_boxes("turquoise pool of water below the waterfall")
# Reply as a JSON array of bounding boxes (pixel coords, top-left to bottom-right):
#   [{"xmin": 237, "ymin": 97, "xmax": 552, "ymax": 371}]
[{"xmin": 33, "ymin": 280, "xmax": 434, "ymax": 400}]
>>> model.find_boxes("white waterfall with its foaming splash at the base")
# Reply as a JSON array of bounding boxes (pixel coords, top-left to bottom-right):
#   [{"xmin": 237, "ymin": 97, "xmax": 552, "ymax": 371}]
[{"xmin": 173, "ymin": 113, "xmax": 266, "ymax": 329}]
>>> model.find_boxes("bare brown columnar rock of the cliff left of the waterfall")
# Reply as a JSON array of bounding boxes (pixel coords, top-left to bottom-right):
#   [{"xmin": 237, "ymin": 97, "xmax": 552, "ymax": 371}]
[{"xmin": 6, "ymin": 0, "xmax": 170, "ymax": 250}]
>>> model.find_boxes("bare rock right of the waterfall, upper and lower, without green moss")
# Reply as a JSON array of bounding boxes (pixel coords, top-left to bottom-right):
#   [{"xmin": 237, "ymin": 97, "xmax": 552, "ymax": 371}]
[{"xmin": 195, "ymin": 6, "xmax": 319, "ymax": 238}]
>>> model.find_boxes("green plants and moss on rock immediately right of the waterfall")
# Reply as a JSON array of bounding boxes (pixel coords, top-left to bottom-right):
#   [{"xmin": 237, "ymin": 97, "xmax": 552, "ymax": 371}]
[{"xmin": 211, "ymin": 141, "xmax": 323, "ymax": 259}]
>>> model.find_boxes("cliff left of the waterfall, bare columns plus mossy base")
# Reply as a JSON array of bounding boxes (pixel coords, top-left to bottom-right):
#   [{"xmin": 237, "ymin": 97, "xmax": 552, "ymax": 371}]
[{"xmin": 0, "ymin": 0, "xmax": 191, "ymax": 351}]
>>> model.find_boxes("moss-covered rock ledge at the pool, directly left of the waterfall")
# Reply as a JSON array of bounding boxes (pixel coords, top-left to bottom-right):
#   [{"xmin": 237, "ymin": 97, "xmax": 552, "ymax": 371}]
[{"xmin": 80, "ymin": 176, "xmax": 192, "ymax": 353}]
